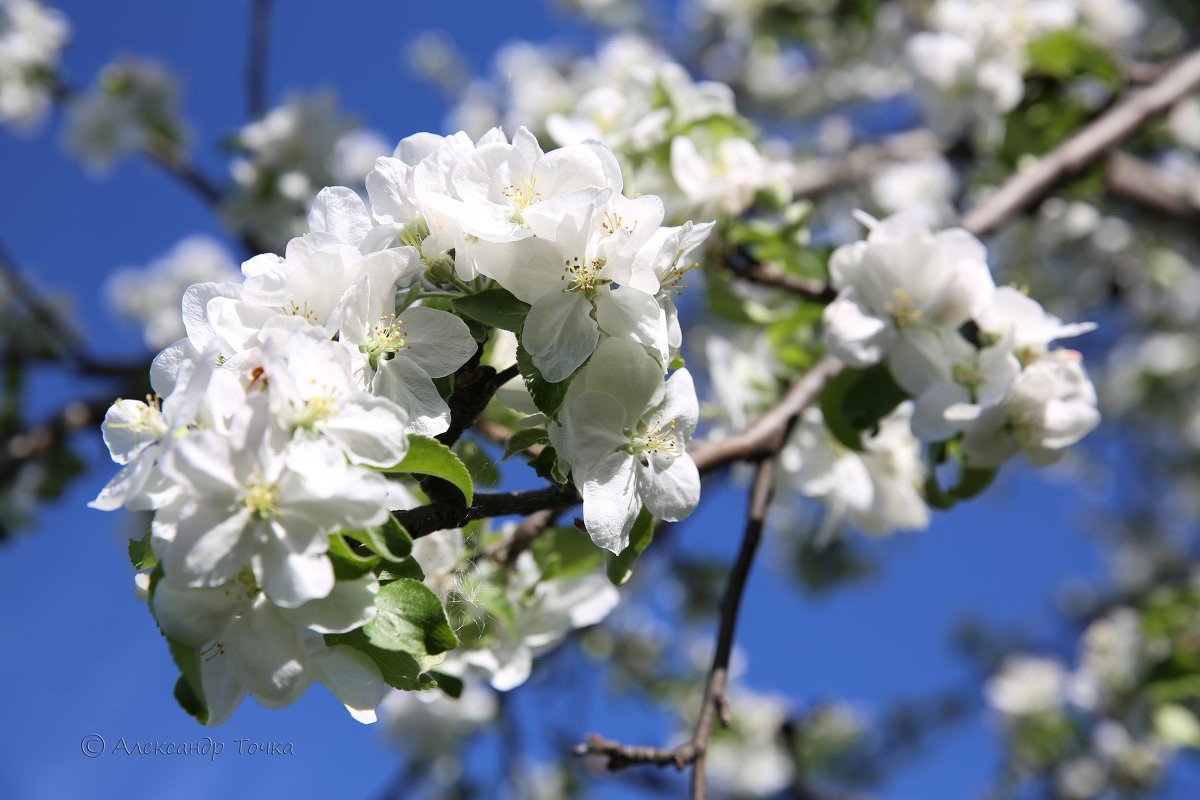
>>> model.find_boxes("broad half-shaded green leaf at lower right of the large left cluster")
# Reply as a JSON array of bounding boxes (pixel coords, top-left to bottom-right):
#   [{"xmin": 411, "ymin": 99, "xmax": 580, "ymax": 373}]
[{"xmin": 362, "ymin": 578, "xmax": 458, "ymax": 669}]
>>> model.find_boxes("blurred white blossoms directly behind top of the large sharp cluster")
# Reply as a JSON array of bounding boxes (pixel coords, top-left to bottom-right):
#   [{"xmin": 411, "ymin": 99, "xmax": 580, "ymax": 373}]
[{"xmin": 436, "ymin": 34, "xmax": 790, "ymax": 221}]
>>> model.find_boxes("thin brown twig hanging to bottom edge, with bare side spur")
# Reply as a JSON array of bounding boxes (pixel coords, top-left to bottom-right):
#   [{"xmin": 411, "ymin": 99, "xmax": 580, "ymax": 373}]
[{"xmin": 575, "ymin": 453, "xmax": 794, "ymax": 800}]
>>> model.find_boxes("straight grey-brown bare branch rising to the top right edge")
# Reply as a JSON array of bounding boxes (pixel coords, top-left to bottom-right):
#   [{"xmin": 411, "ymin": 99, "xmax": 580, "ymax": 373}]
[{"xmin": 960, "ymin": 50, "xmax": 1200, "ymax": 236}]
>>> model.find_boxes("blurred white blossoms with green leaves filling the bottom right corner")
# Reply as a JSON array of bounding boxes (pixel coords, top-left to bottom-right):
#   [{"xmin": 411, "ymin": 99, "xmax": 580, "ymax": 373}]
[{"xmin": 984, "ymin": 592, "xmax": 1200, "ymax": 800}]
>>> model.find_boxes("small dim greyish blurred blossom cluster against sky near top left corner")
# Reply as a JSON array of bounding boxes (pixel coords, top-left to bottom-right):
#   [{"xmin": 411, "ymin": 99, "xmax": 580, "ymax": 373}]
[{"xmin": 66, "ymin": 59, "xmax": 186, "ymax": 170}]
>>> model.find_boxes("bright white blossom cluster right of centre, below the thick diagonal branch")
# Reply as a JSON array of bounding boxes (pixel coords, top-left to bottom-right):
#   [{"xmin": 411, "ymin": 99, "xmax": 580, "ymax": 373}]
[{"xmin": 824, "ymin": 215, "xmax": 1099, "ymax": 469}]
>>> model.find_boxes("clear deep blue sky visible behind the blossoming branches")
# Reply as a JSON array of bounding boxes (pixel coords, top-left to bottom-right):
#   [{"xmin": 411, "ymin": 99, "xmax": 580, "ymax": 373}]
[{"xmin": 0, "ymin": 0, "xmax": 1194, "ymax": 800}]
